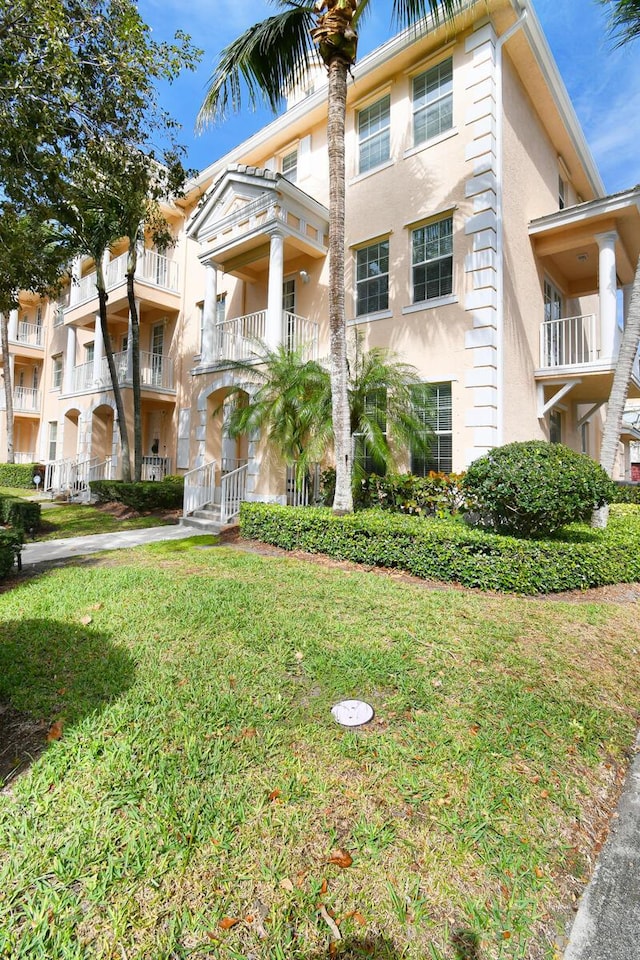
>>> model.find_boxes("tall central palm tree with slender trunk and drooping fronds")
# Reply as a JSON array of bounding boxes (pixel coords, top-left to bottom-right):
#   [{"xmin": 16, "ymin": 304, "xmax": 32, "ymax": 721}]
[{"xmin": 198, "ymin": 0, "xmax": 463, "ymax": 513}]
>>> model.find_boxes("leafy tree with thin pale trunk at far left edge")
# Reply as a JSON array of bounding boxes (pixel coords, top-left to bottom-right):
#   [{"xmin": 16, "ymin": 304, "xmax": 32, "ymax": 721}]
[{"xmin": 0, "ymin": 211, "xmax": 69, "ymax": 463}]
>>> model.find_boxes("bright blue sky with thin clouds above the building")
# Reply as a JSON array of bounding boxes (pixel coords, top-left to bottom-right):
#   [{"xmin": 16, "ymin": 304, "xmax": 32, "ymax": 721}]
[{"xmin": 139, "ymin": 0, "xmax": 640, "ymax": 193}]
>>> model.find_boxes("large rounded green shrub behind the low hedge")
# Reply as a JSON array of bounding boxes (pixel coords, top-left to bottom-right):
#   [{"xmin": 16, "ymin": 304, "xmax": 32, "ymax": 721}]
[{"xmin": 462, "ymin": 440, "xmax": 614, "ymax": 537}]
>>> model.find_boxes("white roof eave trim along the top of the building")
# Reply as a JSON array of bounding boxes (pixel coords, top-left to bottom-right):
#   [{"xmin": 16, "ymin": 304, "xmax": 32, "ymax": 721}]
[{"xmin": 187, "ymin": 0, "xmax": 606, "ymax": 196}]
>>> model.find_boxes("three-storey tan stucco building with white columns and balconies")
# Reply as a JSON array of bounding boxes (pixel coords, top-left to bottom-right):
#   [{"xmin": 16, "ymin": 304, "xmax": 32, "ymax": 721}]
[{"xmin": 0, "ymin": 0, "xmax": 640, "ymax": 516}]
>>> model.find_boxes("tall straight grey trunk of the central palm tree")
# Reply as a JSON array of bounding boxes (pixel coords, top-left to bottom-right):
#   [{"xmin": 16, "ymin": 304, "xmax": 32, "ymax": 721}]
[{"xmin": 328, "ymin": 57, "xmax": 353, "ymax": 513}]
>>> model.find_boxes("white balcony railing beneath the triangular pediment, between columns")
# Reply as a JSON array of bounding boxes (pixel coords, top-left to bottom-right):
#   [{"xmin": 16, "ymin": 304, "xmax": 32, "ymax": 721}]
[{"xmin": 215, "ymin": 310, "xmax": 318, "ymax": 363}]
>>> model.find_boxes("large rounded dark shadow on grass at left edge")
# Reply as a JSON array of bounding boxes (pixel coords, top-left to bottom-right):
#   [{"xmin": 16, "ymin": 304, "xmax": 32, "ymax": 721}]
[{"xmin": 0, "ymin": 619, "xmax": 135, "ymax": 787}]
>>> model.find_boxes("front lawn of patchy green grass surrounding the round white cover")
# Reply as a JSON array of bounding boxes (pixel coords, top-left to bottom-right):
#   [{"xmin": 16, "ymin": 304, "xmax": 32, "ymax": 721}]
[{"xmin": 0, "ymin": 538, "xmax": 640, "ymax": 960}]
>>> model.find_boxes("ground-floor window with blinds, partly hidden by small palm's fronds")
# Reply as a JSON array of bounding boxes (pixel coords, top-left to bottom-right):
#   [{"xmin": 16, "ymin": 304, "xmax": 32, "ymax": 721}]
[{"xmin": 411, "ymin": 383, "xmax": 453, "ymax": 477}]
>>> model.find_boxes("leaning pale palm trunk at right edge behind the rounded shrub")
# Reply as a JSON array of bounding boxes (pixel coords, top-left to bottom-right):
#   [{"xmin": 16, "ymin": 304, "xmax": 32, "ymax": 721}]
[{"xmin": 592, "ymin": 258, "xmax": 640, "ymax": 527}]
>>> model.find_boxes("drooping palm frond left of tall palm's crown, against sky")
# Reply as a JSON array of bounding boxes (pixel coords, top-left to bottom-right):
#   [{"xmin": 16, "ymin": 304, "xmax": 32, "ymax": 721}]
[{"xmin": 196, "ymin": 0, "xmax": 319, "ymax": 129}]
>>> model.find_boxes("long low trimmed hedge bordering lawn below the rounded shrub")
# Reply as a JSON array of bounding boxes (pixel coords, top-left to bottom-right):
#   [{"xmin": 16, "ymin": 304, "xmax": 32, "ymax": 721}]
[{"xmin": 240, "ymin": 503, "xmax": 640, "ymax": 594}]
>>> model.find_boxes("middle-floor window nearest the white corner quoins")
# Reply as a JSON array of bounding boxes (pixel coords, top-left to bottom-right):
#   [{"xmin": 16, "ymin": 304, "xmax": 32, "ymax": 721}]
[{"xmin": 411, "ymin": 217, "xmax": 453, "ymax": 303}]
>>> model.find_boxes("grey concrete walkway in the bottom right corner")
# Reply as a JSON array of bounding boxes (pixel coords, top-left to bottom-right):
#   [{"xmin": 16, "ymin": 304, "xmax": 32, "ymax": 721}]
[{"xmin": 564, "ymin": 740, "xmax": 640, "ymax": 960}]
